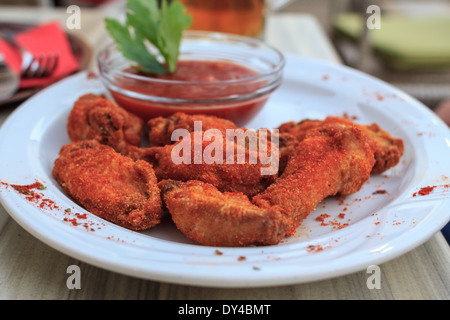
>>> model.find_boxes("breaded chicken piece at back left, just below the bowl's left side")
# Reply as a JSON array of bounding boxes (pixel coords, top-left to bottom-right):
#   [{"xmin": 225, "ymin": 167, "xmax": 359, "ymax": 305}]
[{"xmin": 67, "ymin": 94, "xmax": 144, "ymax": 153}]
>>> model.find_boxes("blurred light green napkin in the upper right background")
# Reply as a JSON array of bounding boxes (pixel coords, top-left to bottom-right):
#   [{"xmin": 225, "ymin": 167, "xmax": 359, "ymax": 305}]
[{"xmin": 333, "ymin": 14, "xmax": 450, "ymax": 69}]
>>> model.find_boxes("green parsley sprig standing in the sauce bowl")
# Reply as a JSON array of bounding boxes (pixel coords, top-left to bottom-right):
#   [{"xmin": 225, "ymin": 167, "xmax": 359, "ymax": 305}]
[{"xmin": 105, "ymin": 0, "xmax": 192, "ymax": 74}]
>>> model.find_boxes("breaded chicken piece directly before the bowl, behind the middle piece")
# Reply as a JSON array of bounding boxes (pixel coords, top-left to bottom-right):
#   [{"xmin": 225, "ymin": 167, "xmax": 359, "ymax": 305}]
[{"xmin": 147, "ymin": 112, "xmax": 237, "ymax": 147}]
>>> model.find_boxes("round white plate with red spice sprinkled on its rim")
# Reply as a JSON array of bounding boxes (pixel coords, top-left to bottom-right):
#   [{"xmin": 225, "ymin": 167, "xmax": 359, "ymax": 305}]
[{"xmin": 0, "ymin": 55, "xmax": 450, "ymax": 287}]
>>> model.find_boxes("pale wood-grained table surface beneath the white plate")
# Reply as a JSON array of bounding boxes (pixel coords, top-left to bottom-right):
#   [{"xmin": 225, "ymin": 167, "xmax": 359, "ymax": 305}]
[{"xmin": 0, "ymin": 1, "xmax": 450, "ymax": 300}]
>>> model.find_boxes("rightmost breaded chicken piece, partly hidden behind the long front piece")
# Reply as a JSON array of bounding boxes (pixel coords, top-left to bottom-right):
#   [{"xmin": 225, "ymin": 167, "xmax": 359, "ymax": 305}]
[{"xmin": 279, "ymin": 117, "xmax": 404, "ymax": 174}]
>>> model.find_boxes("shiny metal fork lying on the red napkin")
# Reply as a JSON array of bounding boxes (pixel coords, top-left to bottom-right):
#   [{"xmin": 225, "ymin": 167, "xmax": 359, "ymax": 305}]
[{"xmin": 0, "ymin": 31, "xmax": 59, "ymax": 78}]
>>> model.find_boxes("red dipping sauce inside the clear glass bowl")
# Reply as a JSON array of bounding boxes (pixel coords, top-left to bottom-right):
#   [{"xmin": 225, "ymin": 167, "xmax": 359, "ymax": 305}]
[{"xmin": 109, "ymin": 60, "xmax": 274, "ymax": 126}]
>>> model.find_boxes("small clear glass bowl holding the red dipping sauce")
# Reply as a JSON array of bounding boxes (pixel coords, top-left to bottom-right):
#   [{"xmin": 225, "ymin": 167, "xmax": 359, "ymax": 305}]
[{"xmin": 97, "ymin": 31, "xmax": 285, "ymax": 126}]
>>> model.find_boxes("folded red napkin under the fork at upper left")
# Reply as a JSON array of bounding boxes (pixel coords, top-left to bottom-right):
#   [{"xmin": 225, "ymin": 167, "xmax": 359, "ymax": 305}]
[{"xmin": 0, "ymin": 22, "xmax": 79, "ymax": 88}]
